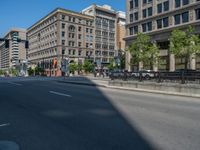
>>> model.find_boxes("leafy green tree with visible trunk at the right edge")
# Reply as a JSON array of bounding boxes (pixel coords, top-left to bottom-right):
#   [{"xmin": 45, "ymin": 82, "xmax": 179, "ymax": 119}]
[{"xmin": 170, "ymin": 26, "xmax": 200, "ymax": 69}]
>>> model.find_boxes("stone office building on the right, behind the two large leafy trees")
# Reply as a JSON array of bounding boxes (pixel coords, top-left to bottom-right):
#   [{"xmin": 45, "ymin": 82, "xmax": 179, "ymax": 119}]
[{"xmin": 125, "ymin": 0, "xmax": 200, "ymax": 71}]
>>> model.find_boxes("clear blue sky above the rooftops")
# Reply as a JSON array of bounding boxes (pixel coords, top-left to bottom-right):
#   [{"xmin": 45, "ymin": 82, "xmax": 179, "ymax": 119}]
[{"xmin": 0, "ymin": 0, "xmax": 126, "ymax": 37}]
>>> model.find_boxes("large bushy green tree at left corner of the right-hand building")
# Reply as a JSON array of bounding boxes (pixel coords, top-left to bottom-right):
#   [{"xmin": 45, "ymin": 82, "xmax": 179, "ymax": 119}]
[{"xmin": 128, "ymin": 33, "xmax": 159, "ymax": 70}]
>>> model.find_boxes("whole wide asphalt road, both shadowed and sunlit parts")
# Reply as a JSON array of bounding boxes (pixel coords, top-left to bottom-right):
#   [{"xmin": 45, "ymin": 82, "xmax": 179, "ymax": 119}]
[{"xmin": 0, "ymin": 80, "xmax": 200, "ymax": 150}]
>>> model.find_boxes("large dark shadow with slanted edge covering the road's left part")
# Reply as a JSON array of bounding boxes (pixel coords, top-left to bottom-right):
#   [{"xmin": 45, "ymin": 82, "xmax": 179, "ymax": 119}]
[{"xmin": 0, "ymin": 78, "xmax": 155, "ymax": 150}]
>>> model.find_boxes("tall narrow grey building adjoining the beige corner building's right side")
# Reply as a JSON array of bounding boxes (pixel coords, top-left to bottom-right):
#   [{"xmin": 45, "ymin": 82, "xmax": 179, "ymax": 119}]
[{"xmin": 82, "ymin": 4, "xmax": 118, "ymax": 67}]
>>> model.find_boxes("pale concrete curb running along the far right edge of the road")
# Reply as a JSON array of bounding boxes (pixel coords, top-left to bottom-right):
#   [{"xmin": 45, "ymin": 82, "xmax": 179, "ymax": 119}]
[{"xmin": 57, "ymin": 81, "xmax": 200, "ymax": 98}]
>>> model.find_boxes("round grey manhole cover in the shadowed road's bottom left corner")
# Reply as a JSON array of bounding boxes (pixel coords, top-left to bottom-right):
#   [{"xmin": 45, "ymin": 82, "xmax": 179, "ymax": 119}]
[{"xmin": 0, "ymin": 141, "xmax": 19, "ymax": 150}]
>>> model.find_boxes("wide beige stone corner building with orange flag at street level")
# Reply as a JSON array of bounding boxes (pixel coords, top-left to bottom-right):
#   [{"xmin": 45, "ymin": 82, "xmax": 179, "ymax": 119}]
[{"xmin": 27, "ymin": 8, "xmax": 95, "ymax": 76}]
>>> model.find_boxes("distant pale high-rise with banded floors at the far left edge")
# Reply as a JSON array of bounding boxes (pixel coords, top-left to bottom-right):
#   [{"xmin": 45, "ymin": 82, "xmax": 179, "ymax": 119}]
[{"xmin": 0, "ymin": 28, "xmax": 27, "ymax": 69}]
